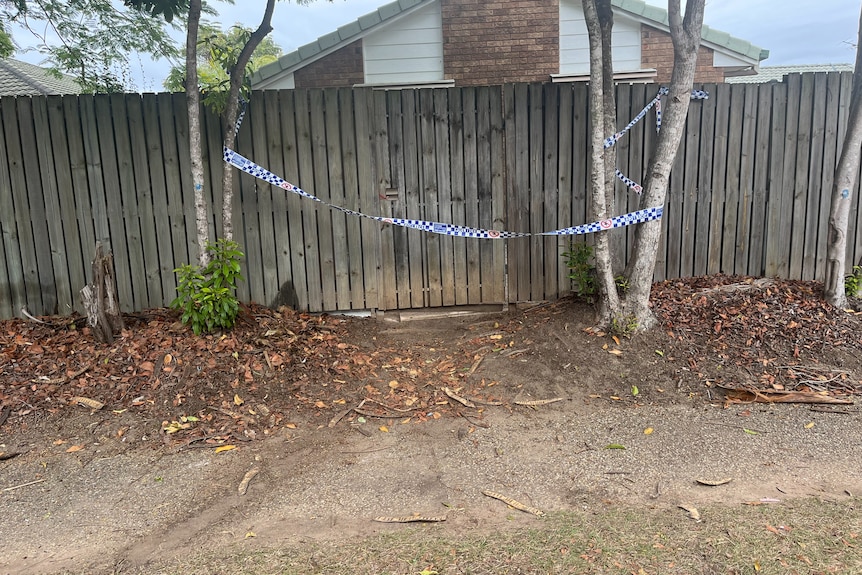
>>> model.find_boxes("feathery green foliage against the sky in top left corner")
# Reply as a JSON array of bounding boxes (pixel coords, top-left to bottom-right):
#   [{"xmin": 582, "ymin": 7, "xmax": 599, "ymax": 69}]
[{"xmin": 0, "ymin": 0, "xmax": 183, "ymax": 92}]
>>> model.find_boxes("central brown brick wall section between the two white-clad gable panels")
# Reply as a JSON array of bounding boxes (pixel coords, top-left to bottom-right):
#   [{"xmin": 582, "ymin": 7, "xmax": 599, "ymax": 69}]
[{"xmin": 441, "ymin": 0, "xmax": 560, "ymax": 86}]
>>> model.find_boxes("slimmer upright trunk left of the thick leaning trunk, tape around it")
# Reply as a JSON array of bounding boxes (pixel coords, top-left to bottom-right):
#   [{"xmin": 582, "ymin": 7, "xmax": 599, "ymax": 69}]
[{"xmin": 583, "ymin": 0, "xmax": 621, "ymax": 326}]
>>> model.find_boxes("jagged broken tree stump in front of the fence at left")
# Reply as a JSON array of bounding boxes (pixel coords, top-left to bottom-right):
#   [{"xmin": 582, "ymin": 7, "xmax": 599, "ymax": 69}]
[{"xmin": 81, "ymin": 242, "xmax": 126, "ymax": 344}]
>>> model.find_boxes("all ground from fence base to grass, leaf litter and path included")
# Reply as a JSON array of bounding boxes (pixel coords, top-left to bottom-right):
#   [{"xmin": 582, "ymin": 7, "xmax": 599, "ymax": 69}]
[{"xmin": 0, "ymin": 276, "xmax": 862, "ymax": 574}]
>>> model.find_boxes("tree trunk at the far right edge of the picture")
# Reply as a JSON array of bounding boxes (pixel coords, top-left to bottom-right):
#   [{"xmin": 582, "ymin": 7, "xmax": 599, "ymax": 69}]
[{"xmin": 824, "ymin": 3, "xmax": 862, "ymax": 309}]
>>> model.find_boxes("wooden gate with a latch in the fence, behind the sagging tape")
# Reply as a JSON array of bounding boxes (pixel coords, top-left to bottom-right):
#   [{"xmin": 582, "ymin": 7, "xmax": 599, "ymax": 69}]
[{"xmin": 375, "ymin": 88, "xmax": 506, "ymax": 310}]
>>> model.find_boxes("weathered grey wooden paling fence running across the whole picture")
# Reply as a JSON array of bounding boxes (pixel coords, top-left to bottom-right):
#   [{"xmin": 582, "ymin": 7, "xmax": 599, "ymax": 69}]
[{"xmin": 0, "ymin": 73, "xmax": 862, "ymax": 318}]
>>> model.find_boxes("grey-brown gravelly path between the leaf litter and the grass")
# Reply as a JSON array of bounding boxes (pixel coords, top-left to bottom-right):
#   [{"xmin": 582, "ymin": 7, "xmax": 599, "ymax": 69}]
[{"xmin": 0, "ymin": 398, "xmax": 862, "ymax": 575}]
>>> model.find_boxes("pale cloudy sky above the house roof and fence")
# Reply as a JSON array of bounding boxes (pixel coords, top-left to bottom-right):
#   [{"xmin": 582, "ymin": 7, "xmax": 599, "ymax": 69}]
[{"xmin": 8, "ymin": 0, "xmax": 860, "ymax": 91}]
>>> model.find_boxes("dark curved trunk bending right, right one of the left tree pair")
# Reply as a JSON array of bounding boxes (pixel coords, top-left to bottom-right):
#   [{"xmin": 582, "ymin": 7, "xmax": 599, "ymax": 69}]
[{"xmin": 222, "ymin": 0, "xmax": 275, "ymax": 241}]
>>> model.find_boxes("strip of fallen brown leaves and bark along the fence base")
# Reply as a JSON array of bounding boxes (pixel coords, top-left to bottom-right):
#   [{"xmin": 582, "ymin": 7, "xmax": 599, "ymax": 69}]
[{"xmin": 0, "ymin": 275, "xmax": 862, "ymax": 447}]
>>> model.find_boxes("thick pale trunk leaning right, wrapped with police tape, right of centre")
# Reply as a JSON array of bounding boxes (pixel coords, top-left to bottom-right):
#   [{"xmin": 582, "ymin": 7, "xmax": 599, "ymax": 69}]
[{"xmin": 626, "ymin": 0, "xmax": 705, "ymax": 331}]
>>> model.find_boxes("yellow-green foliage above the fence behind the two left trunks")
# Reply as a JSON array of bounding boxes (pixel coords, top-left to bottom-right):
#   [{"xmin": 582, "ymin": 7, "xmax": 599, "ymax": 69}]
[{"xmin": 164, "ymin": 24, "xmax": 282, "ymax": 114}]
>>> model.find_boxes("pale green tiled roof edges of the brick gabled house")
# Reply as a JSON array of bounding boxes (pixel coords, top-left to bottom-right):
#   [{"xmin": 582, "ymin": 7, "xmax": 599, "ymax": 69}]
[{"xmin": 251, "ymin": 0, "xmax": 769, "ymax": 86}]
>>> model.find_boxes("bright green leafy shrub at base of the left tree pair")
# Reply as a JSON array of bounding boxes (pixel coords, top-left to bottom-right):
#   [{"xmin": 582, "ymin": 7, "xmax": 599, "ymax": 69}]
[{"xmin": 171, "ymin": 240, "xmax": 244, "ymax": 335}]
